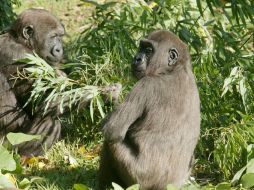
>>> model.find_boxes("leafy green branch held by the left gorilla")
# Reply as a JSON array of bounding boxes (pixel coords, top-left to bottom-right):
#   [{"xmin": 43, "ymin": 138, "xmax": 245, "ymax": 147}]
[{"xmin": 12, "ymin": 54, "xmax": 105, "ymax": 119}]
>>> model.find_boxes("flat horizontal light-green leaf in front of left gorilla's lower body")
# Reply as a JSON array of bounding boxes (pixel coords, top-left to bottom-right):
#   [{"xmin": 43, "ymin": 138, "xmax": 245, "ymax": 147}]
[{"xmin": 6, "ymin": 133, "xmax": 41, "ymax": 145}]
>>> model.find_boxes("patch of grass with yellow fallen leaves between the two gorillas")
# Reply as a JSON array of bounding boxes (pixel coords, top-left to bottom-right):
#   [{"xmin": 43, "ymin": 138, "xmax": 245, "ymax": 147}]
[{"xmin": 19, "ymin": 140, "xmax": 100, "ymax": 190}]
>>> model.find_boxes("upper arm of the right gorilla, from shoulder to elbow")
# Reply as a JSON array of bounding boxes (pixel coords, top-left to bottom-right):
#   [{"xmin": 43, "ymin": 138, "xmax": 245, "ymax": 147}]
[{"xmin": 103, "ymin": 79, "xmax": 148, "ymax": 142}]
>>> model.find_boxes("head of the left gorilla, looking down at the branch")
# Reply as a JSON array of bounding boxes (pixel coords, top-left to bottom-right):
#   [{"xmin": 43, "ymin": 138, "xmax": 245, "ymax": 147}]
[{"xmin": 11, "ymin": 9, "xmax": 64, "ymax": 63}]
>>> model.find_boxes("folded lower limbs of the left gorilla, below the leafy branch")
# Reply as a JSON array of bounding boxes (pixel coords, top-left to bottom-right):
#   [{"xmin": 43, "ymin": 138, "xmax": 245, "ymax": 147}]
[{"xmin": 0, "ymin": 72, "xmax": 61, "ymax": 156}]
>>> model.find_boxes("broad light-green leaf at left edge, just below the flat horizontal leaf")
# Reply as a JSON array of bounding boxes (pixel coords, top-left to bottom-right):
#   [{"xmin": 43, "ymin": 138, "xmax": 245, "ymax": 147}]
[{"xmin": 0, "ymin": 145, "xmax": 16, "ymax": 171}]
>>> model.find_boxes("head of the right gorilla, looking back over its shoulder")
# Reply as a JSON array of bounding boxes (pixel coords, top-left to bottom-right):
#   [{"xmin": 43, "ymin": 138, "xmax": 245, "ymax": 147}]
[{"xmin": 132, "ymin": 30, "xmax": 190, "ymax": 79}]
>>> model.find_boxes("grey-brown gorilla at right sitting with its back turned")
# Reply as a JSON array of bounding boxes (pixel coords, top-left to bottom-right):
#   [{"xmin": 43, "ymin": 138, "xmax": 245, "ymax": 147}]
[{"xmin": 99, "ymin": 31, "xmax": 200, "ymax": 190}]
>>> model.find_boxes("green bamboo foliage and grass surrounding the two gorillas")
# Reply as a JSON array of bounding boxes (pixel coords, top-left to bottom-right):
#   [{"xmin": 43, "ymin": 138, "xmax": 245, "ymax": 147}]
[{"xmin": 0, "ymin": 0, "xmax": 254, "ymax": 189}]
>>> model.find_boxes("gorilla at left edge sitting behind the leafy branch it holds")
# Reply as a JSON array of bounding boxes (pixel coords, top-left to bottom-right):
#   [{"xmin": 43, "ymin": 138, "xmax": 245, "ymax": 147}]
[{"xmin": 0, "ymin": 9, "xmax": 64, "ymax": 155}]
